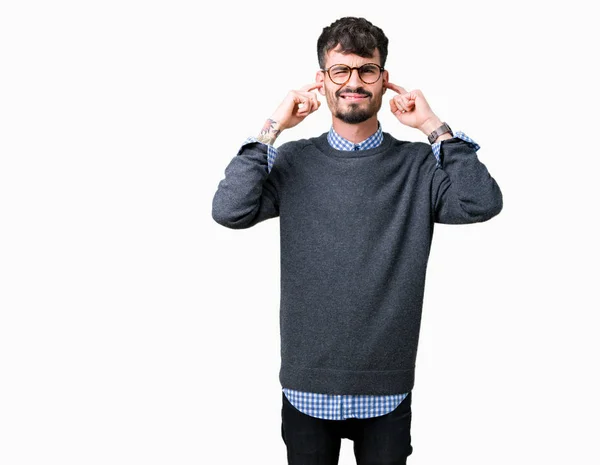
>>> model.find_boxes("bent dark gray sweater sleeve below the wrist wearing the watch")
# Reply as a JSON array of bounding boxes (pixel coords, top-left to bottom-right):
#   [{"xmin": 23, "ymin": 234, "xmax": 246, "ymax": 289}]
[{"xmin": 428, "ymin": 137, "xmax": 503, "ymax": 224}]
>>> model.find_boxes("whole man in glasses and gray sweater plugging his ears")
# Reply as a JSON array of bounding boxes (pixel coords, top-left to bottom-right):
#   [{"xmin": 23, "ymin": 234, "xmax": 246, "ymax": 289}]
[{"xmin": 212, "ymin": 17, "xmax": 503, "ymax": 465}]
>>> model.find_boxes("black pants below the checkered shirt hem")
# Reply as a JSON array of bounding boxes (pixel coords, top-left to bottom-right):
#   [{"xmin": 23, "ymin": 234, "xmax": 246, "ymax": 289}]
[{"xmin": 281, "ymin": 391, "xmax": 413, "ymax": 465}]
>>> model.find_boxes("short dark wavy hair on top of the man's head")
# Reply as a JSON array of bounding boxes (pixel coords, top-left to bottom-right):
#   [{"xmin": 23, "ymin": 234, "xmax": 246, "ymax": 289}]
[{"xmin": 317, "ymin": 16, "xmax": 388, "ymax": 69}]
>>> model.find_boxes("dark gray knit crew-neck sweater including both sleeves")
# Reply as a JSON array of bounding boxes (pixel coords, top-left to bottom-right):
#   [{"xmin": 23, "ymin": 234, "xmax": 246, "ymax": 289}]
[{"xmin": 212, "ymin": 132, "xmax": 502, "ymax": 395}]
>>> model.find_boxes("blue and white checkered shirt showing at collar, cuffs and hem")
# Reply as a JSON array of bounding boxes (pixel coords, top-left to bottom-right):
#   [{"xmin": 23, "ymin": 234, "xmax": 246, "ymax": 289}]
[{"xmin": 242, "ymin": 122, "xmax": 480, "ymax": 420}]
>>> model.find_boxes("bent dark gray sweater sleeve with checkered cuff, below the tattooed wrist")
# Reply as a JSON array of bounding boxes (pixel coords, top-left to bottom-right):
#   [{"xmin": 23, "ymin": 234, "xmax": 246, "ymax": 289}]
[{"xmin": 212, "ymin": 137, "xmax": 279, "ymax": 229}]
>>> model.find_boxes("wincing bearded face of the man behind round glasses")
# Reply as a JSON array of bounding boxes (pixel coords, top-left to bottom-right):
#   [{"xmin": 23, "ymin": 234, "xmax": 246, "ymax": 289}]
[{"xmin": 316, "ymin": 46, "xmax": 388, "ymax": 124}]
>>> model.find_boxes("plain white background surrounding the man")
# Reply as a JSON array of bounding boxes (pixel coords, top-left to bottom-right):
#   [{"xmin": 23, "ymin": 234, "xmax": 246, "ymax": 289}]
[{"xmin": 0, "ymin": 0, "xmax": 600, "ymax": 465}]
